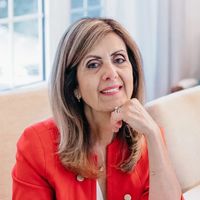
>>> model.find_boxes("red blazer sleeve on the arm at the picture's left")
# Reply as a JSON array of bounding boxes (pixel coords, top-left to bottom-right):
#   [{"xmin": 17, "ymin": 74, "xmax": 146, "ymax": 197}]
[{"xmin": 12, "ymin": 127, "xmax": 54, "ymax": 200}]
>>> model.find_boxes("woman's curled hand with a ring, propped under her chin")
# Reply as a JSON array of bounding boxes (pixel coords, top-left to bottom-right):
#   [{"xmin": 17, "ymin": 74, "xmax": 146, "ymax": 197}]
[{"xmin": 111, "ymin": 98, "xmax": 159, "ymax": 136}]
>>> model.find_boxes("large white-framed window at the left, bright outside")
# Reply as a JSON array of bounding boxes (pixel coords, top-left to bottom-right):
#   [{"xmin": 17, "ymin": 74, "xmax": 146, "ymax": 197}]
[{"xmin": 0, "ymin": 0, "xmax": 45, "ymax": 90}]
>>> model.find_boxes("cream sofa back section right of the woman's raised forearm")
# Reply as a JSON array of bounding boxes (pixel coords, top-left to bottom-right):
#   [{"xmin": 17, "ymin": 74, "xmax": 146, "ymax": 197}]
[{"xmin": 146, "ymin": 86, "xmax": 200, "ymax": 192}]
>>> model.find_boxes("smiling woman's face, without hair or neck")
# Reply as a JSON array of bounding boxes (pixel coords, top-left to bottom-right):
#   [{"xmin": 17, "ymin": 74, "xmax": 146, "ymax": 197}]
[{"xmin": 77, "ymin": 33, "xmax": 133, "ymax": 112}]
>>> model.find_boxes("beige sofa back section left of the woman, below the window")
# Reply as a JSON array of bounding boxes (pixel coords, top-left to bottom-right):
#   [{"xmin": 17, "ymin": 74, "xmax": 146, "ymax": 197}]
[{"xmin": 0, "ymin": 85, "xmax": 51, "ymax": 200}]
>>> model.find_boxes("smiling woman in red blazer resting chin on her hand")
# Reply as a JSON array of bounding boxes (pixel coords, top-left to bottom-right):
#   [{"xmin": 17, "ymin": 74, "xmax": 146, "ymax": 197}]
[{"xmin": 12, "ymin": 18, "xmax": 181, "ymax": 200}]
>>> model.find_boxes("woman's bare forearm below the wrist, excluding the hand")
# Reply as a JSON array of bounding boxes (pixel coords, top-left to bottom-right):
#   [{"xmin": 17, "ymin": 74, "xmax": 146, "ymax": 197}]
[{"xmin": 146, "ymin": 127, "xmax": 181, "ymax": 200}]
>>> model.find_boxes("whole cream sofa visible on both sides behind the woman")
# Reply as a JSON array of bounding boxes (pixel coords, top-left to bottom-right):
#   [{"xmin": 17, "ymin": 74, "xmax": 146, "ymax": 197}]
[{"xmin": 0, "ymin": 84, "xmax": 200, "ymax": 200}]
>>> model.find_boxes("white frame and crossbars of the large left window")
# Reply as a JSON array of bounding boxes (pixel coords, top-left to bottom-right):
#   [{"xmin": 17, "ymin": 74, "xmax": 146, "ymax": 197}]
[{"xmin": 0, "ymin": 0, "xmax": 46, "ymax": 92}]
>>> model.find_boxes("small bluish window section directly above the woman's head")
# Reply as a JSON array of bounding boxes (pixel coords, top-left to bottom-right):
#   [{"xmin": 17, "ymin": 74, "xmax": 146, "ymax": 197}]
[{"xmin": 71, "ymin": 0, "xmax": 102, "ymax": 22}]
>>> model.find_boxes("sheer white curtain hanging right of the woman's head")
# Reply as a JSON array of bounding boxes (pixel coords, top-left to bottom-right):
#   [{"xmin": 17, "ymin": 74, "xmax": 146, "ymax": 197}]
[{"xmin": 106, "ymin": 0, "xmax": 200, "ymax": 101}]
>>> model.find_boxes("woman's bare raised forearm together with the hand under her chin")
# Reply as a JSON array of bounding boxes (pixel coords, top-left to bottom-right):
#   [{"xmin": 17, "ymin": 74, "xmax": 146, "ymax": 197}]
[{"xmin": 111, "ymin": 99, "xmax": 181, "ymax": 200}]
